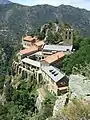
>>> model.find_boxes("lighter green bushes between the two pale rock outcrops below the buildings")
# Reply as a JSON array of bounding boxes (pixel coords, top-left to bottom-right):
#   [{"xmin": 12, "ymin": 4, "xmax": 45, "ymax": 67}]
[{"xmin": 30, "ymin": 91, "xmax": 56, "ymax": 120}]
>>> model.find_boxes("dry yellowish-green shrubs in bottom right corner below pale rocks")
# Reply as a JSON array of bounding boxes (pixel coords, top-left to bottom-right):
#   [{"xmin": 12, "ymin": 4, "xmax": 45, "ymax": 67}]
[{"xmin": 48, "ymin": 98, "xmax": 90, "ymax": 120}]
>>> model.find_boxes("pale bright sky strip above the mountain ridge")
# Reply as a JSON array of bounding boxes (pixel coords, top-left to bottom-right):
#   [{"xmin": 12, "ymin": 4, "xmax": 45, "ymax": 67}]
[{"xmin": 11, "ymin": 0, "xmax": 90, "ymax": 10}]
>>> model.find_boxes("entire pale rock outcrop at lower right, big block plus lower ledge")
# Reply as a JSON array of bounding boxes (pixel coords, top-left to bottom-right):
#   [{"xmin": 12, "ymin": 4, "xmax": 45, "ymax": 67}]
[{"xmin": 53, "ymin": 75, "xmax": 90, "ymax": 117}]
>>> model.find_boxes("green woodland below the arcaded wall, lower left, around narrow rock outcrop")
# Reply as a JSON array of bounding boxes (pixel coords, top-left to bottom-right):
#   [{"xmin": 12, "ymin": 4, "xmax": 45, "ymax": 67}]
[{"xmin": 0, "ymin": 74, "xmax": 56, "ymax": 120}]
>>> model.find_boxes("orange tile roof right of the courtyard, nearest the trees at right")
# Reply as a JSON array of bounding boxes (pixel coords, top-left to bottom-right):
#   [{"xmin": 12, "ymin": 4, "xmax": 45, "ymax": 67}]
[{"xmin": 42, "ymin": 52, "xmax": 65, "ymax": 64}]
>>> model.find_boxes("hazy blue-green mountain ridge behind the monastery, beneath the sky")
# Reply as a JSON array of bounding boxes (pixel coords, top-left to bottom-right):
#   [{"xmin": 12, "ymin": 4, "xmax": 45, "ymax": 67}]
[{"xmin": 0, "ymin": 3, "xmax": 90, "ymax": 45}]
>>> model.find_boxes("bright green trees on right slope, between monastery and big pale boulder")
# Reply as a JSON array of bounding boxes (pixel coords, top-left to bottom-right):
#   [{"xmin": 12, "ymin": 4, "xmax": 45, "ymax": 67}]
[{"xmin": 62, "ymin": 38, "xmax": 90, "ymax": 77}]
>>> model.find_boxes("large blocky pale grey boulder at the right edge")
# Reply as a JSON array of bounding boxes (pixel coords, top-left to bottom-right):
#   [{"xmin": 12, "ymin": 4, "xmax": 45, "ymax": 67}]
[{"xmin": 69, "ymin": 75, "xmax": 90, "ymax": 99}]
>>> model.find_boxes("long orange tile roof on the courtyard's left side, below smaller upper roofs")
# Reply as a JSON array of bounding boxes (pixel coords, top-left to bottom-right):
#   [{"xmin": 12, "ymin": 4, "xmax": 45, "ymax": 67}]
[{"xmin": 19, "ymin": 46, "xmax": 38, "ymax": 55}]
